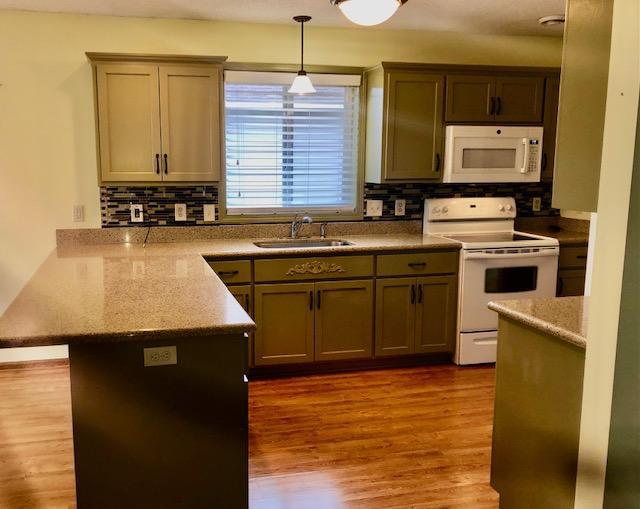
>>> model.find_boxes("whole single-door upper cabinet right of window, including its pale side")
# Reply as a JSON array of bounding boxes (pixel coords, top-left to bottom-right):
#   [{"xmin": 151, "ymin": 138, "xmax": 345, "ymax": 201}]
[{"xmin": 366, "ymin": 67, "xmax": 445, "ymax": 183}]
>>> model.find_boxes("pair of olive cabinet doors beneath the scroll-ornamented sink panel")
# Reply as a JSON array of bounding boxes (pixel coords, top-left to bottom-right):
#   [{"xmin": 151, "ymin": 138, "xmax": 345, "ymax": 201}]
[{"xmin": 255, "ymin": 280, "xmax": 373, "ymax": 366}]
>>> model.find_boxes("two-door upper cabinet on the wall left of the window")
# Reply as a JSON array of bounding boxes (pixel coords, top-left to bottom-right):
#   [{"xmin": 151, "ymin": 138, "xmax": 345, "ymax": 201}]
[{"xmin": 90, "ymin": 56, "xmax": 222, "ymax": 184}]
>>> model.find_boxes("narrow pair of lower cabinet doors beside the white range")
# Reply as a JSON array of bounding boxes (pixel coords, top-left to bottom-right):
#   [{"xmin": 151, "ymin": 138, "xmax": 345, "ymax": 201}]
[{"xmin": 375, "ymin": 275, "xmax": 457, "ymax": 356}]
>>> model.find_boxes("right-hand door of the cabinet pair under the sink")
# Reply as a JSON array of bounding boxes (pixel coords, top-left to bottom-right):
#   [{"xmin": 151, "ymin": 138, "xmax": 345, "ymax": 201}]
[{"xmin": 315, "ymin": 281, "xmax": 373, "ymax": 361}]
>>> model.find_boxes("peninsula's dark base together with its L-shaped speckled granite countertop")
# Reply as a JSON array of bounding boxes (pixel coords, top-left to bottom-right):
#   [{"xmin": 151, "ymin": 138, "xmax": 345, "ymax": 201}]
[{"xmin": 0, "ymin": 232, "xmax": 458, "ymax": 509}]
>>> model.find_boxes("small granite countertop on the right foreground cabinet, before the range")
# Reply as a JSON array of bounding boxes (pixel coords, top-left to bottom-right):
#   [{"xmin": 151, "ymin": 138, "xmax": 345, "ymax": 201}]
[{"xmin": 489, "ymin": 297, "xmax": 588, "ymax": 348}]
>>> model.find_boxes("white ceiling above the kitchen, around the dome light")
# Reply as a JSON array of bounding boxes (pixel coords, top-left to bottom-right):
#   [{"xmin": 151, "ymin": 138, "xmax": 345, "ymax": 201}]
[{"xmin": 0, "ymin": 0, "xmax": 565, "ymax": 36}]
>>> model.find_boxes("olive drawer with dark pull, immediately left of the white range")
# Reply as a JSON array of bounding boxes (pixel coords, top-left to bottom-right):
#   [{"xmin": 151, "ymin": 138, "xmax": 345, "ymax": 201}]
[{"xmin": 377, "ymin": 251, "xmax": 458, "ymax": 276}]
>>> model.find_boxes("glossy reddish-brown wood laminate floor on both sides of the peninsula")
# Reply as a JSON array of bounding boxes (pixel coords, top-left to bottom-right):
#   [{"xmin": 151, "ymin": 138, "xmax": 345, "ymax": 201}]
[{"xmin": 0, "ymin": 363, "xmax": 498, "ymax": 509}]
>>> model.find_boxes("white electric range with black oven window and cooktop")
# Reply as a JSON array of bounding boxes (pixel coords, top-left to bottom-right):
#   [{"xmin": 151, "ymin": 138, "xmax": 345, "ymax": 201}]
[{"xmin": 423, "ymin": 197, "xmax": 559, "ymax": 365}]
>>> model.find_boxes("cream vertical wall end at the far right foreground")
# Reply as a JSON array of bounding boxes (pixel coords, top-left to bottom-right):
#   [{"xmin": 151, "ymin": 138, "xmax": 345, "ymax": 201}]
[{"xmin": 575, "ymin": 0, "xmax": 640, "ymax": 509}]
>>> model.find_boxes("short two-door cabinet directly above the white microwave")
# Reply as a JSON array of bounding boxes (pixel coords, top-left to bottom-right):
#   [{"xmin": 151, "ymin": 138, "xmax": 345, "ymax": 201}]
[{"xmin": 445, "ymin": 74, "xmax": 544, "ymax": 124}]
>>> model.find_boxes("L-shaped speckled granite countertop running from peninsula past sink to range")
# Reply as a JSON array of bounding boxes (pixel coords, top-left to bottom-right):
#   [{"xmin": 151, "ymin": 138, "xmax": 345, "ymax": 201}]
[{"xmin": 0, "ymin": 234, "xmax": 459, "ymax": 347}]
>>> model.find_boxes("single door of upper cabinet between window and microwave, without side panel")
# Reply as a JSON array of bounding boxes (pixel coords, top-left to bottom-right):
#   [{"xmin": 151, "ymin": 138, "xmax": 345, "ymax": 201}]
[{"xmin": 384, "ymin": 72, "xmax": 444, "ymax": 181}]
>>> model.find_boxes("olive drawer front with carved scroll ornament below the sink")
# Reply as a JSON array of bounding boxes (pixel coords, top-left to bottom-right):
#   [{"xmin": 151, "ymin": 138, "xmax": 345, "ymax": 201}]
[{"xmin": 255, "ymin": 256, "xmax": 373, "ymax": 282}]
